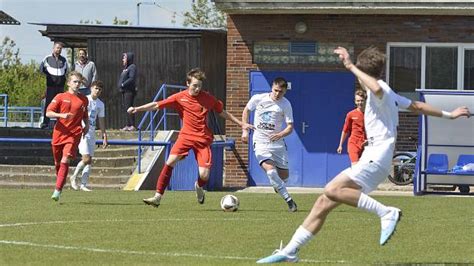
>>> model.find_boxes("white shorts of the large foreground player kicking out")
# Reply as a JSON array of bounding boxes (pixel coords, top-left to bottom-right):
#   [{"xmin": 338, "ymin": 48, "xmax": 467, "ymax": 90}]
[{"xmin": 342, "ymin": 161, "xmax": 389, "ymax": 194}]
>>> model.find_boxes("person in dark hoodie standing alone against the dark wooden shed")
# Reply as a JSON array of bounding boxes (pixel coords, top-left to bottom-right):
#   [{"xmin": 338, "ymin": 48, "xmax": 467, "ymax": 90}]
[{"xmin": 118, "ymin": 52, "xmax": 137, "ymax": 131}]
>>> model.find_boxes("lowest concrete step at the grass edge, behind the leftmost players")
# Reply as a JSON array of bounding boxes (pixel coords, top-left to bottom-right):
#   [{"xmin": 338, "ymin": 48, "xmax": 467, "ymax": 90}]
[{"xmin": 0, "ymin": 173, "xmax": 130, "ymax": 185}]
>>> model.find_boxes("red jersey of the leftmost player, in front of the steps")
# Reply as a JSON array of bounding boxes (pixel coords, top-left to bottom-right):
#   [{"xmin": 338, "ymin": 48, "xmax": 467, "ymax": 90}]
[{"xmin": 47, "ymin": 92, "xmax": 89, "ymax": 145}]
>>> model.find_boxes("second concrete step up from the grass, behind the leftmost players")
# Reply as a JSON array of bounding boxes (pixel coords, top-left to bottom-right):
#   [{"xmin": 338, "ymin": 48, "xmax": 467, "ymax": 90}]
[{"xmin": 0, "ymin": 164, "xmax": 134, "ymax": 176}]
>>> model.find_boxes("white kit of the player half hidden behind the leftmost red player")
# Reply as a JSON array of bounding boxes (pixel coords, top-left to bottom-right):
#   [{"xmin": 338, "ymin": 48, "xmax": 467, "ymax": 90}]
[{"xmin": 79, "ymin": 95, "xmax": 105, "ymax": 156}]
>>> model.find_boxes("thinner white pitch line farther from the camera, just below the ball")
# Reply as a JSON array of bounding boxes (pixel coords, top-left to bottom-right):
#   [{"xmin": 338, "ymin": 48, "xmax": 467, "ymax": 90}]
[{"xmin": 0, "ymin": 218, "xmax": 287, "ymax": 228}]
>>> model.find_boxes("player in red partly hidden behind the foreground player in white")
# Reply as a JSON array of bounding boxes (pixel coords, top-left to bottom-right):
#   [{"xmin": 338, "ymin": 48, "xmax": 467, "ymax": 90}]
[{"xmin": 337, "ymin": 90, "xmax": 367, "ymax": 164}]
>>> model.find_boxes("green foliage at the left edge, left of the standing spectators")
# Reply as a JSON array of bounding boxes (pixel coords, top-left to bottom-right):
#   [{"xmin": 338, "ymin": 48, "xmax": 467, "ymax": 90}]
[{"xmin": 0, "ymin": 37, "xmax": 46, "ymax": 106}]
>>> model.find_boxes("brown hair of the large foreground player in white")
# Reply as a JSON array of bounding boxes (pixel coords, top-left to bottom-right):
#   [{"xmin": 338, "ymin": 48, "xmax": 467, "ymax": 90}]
[{"xmin": 356, "ymin": 46, "xmax": 385, "ymax": 79}]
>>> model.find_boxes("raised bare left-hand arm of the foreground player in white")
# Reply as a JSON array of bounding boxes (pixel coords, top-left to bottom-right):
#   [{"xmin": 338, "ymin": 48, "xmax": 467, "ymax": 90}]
[{"xmin": 334, "ymin": 47, "xmax": 383, "ymax": 98}]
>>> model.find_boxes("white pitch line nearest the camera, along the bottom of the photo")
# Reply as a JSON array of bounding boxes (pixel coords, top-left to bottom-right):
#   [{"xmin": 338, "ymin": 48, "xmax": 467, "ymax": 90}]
[{"xmin": 0, "ymin": 240, "xmax": 347, "ymax": 263}]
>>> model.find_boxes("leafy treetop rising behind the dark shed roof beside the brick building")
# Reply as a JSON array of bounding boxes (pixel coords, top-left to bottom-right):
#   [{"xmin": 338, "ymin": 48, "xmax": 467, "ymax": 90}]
[{"xmin": 183, "ymin": 0, "xmax": 227, "ymax": 28}]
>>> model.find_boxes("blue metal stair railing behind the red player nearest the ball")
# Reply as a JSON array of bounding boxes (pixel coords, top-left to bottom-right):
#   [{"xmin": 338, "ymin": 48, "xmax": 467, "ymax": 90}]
[{"xmin": 137, "ymin": 84, "xmax": 186, "ymax": 173}]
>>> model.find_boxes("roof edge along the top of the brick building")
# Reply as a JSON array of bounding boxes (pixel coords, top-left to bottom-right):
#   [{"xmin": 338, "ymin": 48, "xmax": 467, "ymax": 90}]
[{"xmin": 213, "ymin": 0, "xmax": 474, "ymax": 16}]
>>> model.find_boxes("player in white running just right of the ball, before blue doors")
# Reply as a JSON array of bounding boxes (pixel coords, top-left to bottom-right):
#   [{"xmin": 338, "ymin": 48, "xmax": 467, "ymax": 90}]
[{"xmin": 242, "ymin": 78, "xmax": 297, "ymax": 212}]
